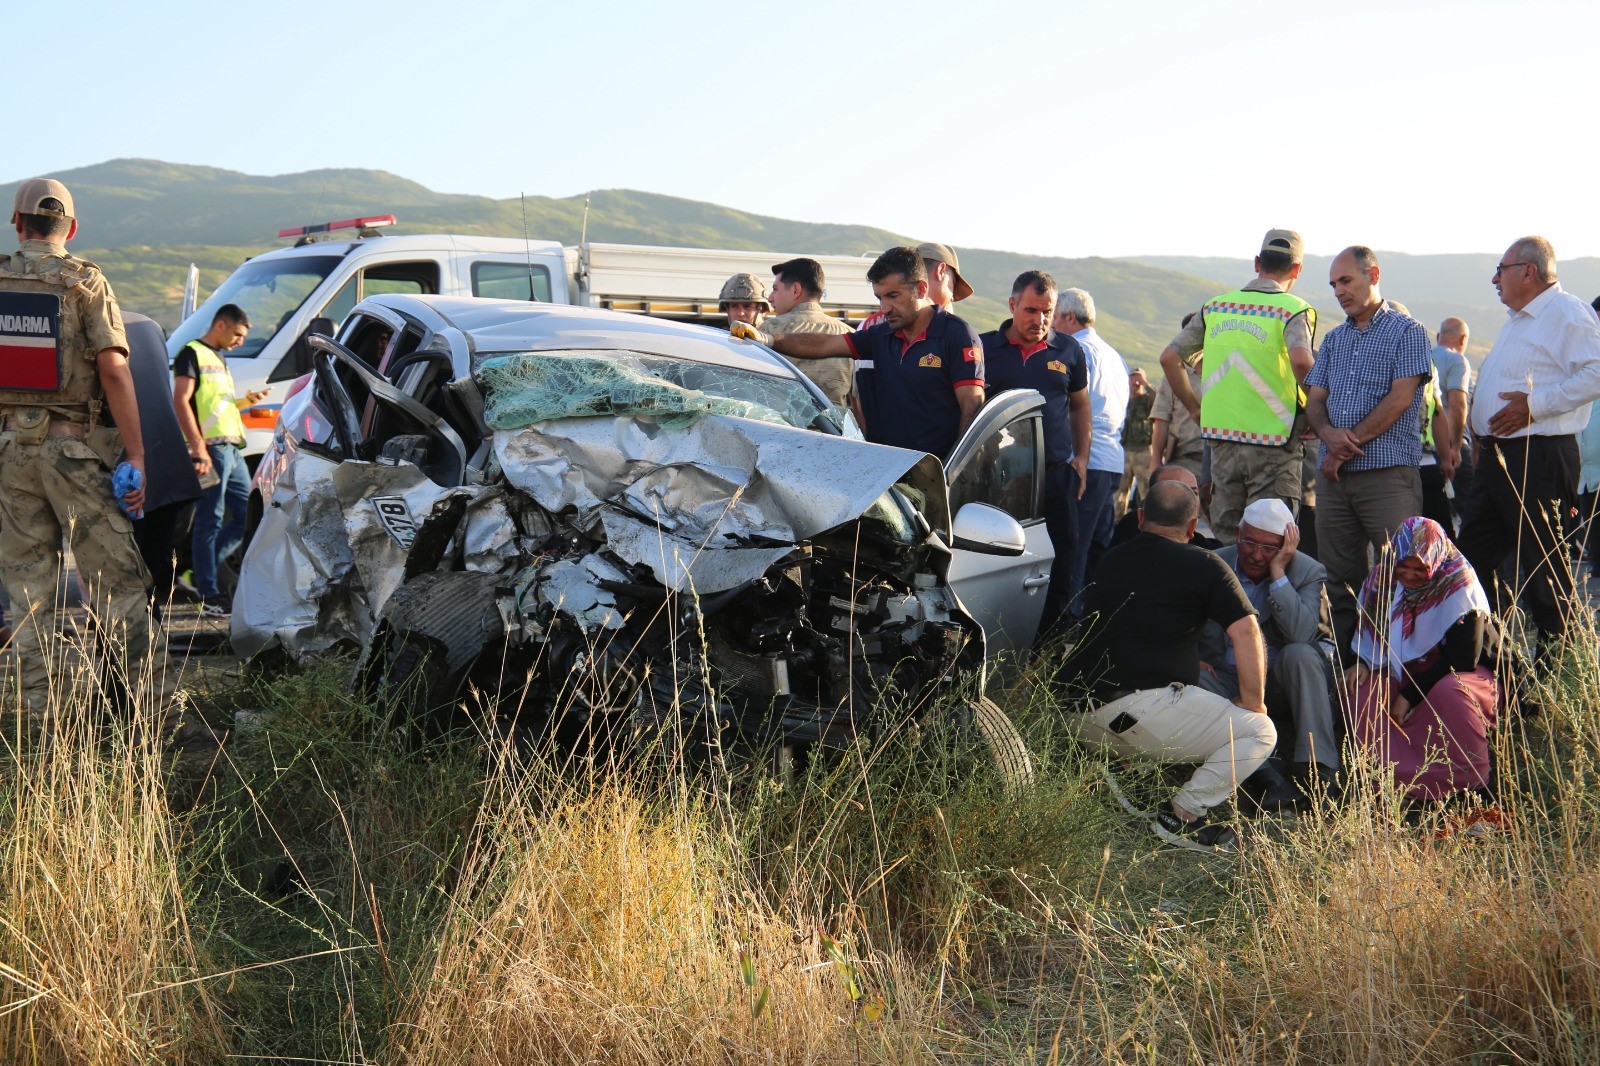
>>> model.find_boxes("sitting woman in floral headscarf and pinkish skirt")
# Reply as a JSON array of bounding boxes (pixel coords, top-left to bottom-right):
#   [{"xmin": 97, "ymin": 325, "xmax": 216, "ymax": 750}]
[{"xmin": 1344, "ymin": 517, "xmax": 1499, "ymax": 799}]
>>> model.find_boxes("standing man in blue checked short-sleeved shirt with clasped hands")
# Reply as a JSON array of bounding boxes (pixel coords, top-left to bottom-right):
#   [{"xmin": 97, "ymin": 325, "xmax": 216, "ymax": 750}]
[{"xmin": 1306, "ymin": 245, "xmax": 1433, "ymax": 655}]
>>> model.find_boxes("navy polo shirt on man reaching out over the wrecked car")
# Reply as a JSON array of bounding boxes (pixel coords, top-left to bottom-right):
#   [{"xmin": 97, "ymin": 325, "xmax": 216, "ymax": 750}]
[{"xmin": 845, "ymin": 307, "xmax": 984, "ymax": 459}]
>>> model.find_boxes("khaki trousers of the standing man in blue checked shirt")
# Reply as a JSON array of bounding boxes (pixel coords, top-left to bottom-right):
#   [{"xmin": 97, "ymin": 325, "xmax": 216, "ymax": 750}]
[{"xmin": 1317, "ymin": 466, "xmax": 1422, "ymax": 646}]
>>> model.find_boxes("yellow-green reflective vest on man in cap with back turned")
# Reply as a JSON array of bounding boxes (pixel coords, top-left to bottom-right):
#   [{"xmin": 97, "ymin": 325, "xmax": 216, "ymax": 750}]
[{"xmin": 1200, "ymin": 288, "xmax": 1317, "ymax": 445}]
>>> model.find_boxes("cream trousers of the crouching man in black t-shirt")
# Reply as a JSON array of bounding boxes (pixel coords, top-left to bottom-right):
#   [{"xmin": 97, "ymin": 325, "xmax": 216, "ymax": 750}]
[{"xmin": 1078, "ymin": 683, "xmax": 1278, "ymax": 815}]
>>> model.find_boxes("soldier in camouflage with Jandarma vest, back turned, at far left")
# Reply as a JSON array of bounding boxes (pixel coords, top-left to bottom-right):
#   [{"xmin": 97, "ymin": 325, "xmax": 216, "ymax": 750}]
[{"xmin": 0, "ymin": 178, "xmax": 174, "ymax": 728}]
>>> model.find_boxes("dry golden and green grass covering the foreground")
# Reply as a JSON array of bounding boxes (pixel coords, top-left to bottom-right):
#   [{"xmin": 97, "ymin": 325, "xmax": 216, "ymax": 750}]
[{"xmin": 0, "ymin": 592, "xmax": 1600, "ymax": 1064}]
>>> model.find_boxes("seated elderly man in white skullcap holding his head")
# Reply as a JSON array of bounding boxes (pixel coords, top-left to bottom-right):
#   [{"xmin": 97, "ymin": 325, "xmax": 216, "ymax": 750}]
[{"xmin": 1200, "ymin": 498, "xmax": 1339, "ymax": 807}]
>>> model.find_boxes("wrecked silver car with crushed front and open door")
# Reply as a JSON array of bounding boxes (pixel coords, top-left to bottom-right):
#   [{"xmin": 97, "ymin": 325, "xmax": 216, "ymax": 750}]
[{"xmin": 232, "ymin": 296, "xmax": 1051, "ymax": 771}]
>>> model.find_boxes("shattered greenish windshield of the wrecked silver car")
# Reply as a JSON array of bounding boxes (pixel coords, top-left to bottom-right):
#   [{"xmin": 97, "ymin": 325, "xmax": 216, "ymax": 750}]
[{"xmin": 474, "ymin": 351, "xmax": 840, "ymax": 434}]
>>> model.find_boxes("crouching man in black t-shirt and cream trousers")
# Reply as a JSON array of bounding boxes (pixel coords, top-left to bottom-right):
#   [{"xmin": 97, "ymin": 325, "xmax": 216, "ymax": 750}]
[{"xmin": 1070, "ymin": 482, "xmax": 1277, "ymax": 850}]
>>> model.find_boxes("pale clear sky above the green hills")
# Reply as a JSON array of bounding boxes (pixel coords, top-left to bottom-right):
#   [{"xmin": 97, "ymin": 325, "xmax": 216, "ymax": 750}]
[{"xmin": 12, "ymin": 0, "xmax": 1600, "ymax": 258}]
